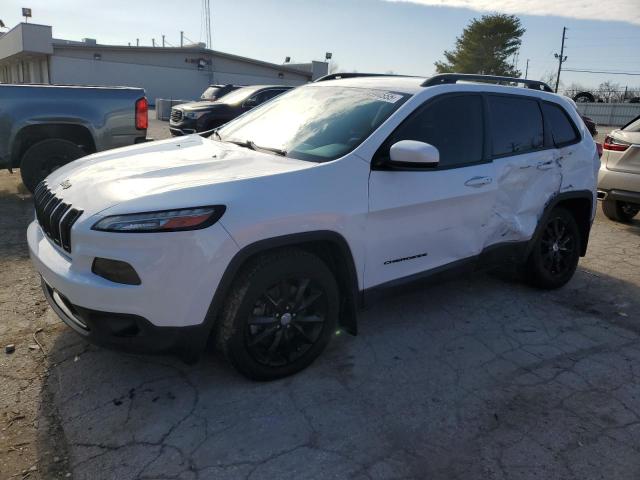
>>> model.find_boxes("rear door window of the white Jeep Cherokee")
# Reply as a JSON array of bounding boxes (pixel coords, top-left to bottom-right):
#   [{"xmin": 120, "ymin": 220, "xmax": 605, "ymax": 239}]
[{"xmin": 489, "ymin": 96, "xmax": 544, "ymax": 156}]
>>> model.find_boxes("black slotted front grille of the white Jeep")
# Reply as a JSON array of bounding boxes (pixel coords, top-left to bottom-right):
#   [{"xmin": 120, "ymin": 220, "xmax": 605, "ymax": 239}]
[{"xmin": 33, "ymin": 182, "xmax": 82, "ymax": 253}]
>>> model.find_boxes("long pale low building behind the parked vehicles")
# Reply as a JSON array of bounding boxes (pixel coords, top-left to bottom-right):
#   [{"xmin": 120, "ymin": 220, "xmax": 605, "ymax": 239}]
[{"xmin": 0, "ymin": 23, "xmax": 328, "ymax": 103}]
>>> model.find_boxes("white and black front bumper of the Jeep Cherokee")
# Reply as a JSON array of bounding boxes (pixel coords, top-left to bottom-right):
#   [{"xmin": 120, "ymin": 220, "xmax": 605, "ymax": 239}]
[{"xmin": 27, "ymin": 221, "xmax": 237, "ymax": 352}]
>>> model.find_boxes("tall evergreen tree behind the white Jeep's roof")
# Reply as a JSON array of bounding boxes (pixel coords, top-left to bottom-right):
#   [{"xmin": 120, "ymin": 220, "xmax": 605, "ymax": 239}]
[{"xmin": 435, "ymin": 14, "xmax": 525, "ymax": 77}]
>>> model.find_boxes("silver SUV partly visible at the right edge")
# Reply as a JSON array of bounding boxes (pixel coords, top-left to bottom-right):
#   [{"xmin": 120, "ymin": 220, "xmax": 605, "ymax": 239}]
[{"xmin": 598, "ymin": 116, "xmax": 640, "ymax": 222}]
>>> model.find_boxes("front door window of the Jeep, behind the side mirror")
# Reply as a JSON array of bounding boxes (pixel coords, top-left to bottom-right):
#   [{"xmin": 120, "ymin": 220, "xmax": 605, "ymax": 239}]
[{"xmin": 386, "ymin": 95, "xmax": 484, "ymax": 168}]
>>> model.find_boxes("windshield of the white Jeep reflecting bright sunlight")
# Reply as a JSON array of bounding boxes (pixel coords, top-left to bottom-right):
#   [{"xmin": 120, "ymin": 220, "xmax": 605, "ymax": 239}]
[{"xmin": 218, "ymin": 86, "xmax": 408, "ymax": 162}]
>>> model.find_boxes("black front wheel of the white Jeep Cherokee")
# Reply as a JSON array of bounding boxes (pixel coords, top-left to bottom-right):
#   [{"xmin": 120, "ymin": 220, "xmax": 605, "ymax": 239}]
[{"xmin": 216, "ymin": 249, "xmax": 340, "ymax": 380}]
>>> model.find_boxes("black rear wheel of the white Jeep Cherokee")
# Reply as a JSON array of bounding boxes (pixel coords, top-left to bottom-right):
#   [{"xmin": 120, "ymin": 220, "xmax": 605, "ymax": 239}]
[{"xmin": 526, "ymin": 208, "xmax": 581, "ymax": 289}]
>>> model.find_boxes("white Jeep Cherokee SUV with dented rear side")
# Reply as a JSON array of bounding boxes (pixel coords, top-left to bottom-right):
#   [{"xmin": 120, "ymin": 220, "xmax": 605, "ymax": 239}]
[{"xmin": 28, "ymin": 74, "xmax": 599, "ymax": 379}]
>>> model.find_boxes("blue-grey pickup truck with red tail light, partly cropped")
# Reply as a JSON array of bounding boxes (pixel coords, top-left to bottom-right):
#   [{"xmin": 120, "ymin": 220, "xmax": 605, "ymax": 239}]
[{"xmin": 0, "ymin": 84, "xmax": 148, "ymax": 192}]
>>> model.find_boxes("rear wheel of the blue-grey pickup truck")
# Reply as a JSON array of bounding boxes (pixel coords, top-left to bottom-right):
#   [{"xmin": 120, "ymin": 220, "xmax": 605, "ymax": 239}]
[{"xmin": 20, "ymin": 138, "xmax": 86, "ymax": 192}]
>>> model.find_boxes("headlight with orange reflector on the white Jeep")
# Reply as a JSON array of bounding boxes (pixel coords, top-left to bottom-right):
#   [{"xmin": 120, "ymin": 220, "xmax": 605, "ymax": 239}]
[{"xmin": 91, "ymin": 205, "xmax": 226, "ymax": 233}]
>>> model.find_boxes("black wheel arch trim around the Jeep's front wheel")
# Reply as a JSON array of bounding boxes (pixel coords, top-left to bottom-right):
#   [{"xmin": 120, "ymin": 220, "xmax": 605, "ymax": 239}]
[{"xmin": 201, "ymin": 230, "xmax": 362, "ymax": 349}]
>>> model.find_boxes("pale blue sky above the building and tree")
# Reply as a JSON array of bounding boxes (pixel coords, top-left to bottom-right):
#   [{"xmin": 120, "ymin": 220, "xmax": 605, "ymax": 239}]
[{"xmin": 0, "ymin": 0, "xmax": 640, "ymax": 88}]
